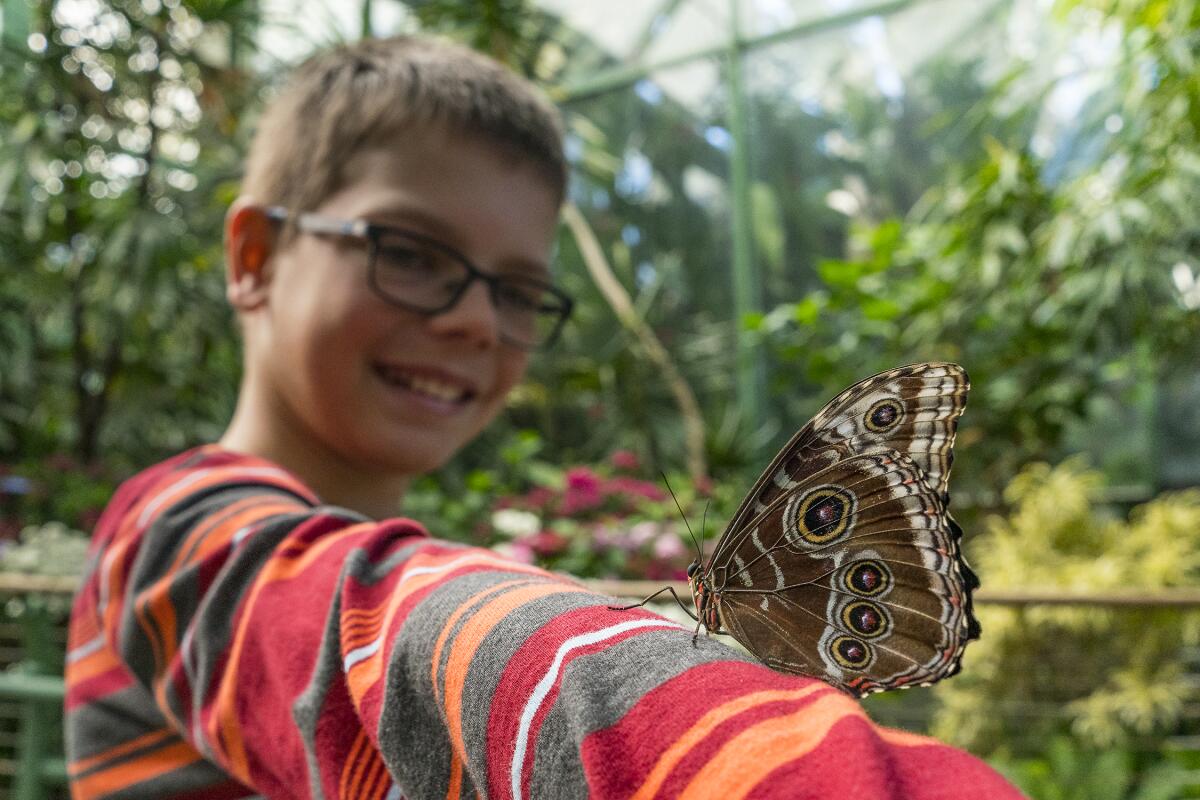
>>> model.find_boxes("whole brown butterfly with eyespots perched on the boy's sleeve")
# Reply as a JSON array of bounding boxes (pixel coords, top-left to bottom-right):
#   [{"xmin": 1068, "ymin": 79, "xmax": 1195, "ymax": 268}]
[{"xmin": 626, "ymin": 363, "xmax": 979, "ymax": 697}]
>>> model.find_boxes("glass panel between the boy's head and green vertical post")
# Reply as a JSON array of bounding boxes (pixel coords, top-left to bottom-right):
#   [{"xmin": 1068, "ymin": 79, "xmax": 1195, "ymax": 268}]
[{"xmin": 526, "ymin": 61, "xmax": 733, "ymax": 463}]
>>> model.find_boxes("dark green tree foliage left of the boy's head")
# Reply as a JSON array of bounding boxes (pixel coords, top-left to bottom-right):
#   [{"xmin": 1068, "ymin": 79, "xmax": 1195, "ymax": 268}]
[{"xmin": 0, "ymin": 0, "xmax": 258, "ymax": 474}]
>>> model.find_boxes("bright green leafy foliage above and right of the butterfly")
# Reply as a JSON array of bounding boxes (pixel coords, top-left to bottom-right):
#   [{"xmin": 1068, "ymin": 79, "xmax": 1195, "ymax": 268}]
[{"xmin": 763, "ymin": 0, "xmax": 1200, "ymax": 488}]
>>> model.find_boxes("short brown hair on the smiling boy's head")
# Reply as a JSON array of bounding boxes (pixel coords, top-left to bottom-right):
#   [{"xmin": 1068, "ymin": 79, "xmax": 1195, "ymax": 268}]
[{"xmin": 242, "ymin": 36, "xmax": 566, "ymax": 217}]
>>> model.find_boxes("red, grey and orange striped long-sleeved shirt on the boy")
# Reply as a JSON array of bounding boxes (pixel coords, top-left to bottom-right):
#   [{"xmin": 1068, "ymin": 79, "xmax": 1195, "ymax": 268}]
[{"xmin": 66, "ymin": 446, "xmax": 1020, "ymax": 800}]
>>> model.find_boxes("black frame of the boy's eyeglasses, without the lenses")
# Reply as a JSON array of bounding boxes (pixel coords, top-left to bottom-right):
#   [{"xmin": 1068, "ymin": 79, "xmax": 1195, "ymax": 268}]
[{"xmin": 265, "ymin": 205, "xmax": 575, "ymax": 350}]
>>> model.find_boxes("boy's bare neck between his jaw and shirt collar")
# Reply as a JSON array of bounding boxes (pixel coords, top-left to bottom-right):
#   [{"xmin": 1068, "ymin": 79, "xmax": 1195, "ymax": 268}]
[{"xmin": 220, "ymin": 385, "xmax": 409, "ymax": 519}]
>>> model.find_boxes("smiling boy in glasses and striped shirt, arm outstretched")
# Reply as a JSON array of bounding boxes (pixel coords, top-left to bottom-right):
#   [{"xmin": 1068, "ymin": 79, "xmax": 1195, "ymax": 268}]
[{"xmin": 66, "ymin": 38, "xmax": 1019, "ymax": 799}]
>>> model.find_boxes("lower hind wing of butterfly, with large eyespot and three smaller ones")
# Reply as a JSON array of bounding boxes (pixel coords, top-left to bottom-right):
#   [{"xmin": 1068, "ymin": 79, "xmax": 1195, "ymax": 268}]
[{"xmin": 708, "ymin": 450, "xmax": 978, "ymax": 696}]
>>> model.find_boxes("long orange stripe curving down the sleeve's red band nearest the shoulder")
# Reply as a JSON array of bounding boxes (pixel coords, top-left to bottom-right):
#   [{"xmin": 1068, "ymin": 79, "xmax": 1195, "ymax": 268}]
[{"xmin": 205, "ymin": 522, "xmax": 376, "ymax": 783}]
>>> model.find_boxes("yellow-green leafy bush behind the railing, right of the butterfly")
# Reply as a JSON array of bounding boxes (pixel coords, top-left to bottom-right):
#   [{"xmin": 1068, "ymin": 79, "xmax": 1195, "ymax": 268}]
[{"xmin": 934, "ymin": 462, "xmax": 1200, "ymax": 754}]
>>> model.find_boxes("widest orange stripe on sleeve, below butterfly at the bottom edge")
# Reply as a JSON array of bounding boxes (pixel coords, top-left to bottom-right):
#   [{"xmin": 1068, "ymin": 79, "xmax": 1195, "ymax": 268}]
[{"xmin": 679, "ymin": 692, "xmax": 866, "ymax": 800}]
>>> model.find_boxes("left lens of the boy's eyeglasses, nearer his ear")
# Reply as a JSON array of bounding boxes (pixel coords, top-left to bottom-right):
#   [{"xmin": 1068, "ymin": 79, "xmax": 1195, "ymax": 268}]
[{"xmin": 373, "ymin": 233, "xmax": 469, "ymax": 311}]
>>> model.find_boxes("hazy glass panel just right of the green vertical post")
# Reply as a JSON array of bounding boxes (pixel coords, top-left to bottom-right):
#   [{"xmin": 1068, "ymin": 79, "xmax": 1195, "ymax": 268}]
[{"xmin": 744, "ymin": 0, "xmax": 1009, "ymax": 308}]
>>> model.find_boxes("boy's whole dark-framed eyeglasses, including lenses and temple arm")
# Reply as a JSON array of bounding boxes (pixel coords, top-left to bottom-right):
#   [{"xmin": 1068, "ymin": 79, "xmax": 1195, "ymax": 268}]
[{"xmin": 266, "ymin": 206, "xmax": 575, "ymax": 350}]
